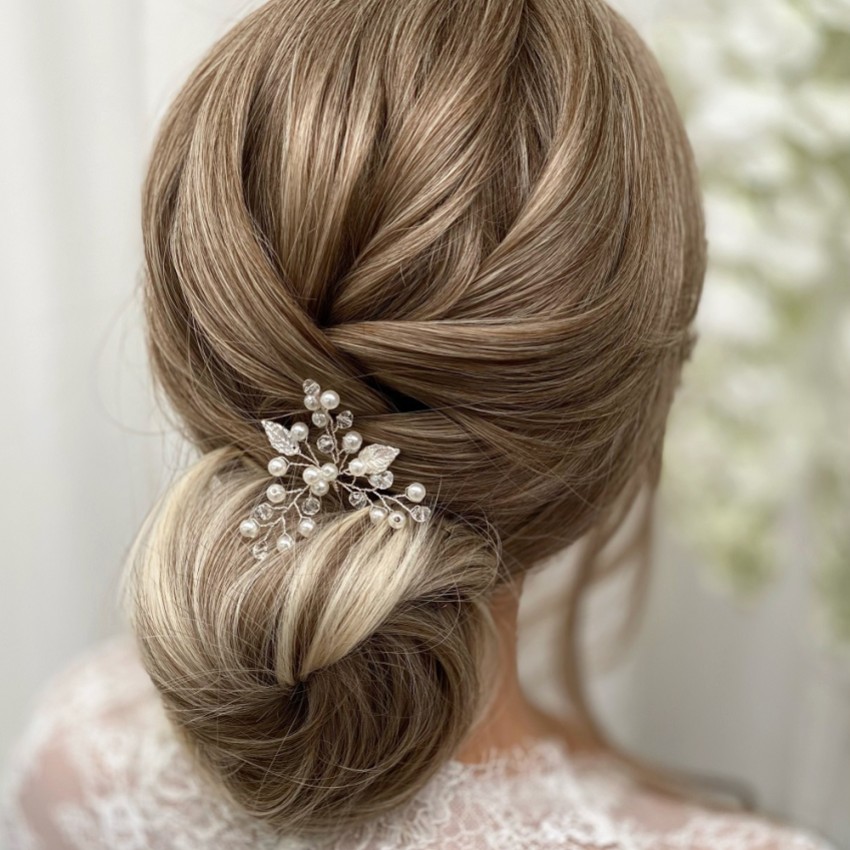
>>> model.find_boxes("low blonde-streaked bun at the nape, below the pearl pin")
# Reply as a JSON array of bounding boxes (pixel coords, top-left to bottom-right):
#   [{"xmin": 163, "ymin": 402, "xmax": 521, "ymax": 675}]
[{"xmin": 129, "ymin": 450, "xmax": 498, "ymax": 834}]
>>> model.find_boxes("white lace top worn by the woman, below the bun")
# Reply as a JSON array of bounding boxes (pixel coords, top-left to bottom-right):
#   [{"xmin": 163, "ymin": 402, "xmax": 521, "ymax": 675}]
[{"xmin": 0, "ymin": 639, "xmax": 829, "ymax": 850}]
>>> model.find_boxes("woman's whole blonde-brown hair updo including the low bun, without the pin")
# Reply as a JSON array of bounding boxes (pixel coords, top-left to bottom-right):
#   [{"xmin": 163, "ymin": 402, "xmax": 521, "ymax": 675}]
[{"xmin": 129, "ymin": 0, "xmax": 704, "ymax": 834}]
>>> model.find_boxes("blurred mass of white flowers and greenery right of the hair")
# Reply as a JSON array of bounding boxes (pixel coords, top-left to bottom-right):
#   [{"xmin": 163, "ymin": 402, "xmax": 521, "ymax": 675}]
[{"xmin": 650, "ymin": 0, "xmax": 850, "ymax": 640}]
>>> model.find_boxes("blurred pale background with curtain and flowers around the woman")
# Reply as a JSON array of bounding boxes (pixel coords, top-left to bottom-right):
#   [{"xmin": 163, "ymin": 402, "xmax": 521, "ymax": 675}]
[{"xmin": 0, "ymin": 0, "xmax": 850, "ymax": 848}]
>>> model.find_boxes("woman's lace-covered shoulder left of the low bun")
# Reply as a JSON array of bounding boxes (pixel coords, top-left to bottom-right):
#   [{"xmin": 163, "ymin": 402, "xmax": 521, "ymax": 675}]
[{"xmin": 0, "ymin": 637, "xmax": 270, "ymax": 850}]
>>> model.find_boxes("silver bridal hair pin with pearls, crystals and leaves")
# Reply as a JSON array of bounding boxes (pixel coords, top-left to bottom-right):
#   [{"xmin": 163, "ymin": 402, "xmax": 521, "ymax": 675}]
[{"xmin": 239, "ymin": 379, "xmax": 431, "ymax": 561}]
